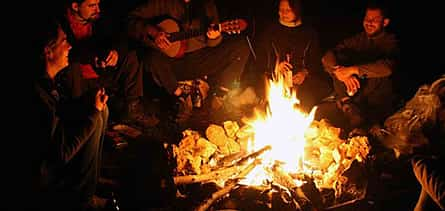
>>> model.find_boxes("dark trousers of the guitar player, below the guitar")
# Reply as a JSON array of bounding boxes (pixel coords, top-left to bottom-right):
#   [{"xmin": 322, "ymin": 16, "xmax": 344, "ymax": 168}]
[{"xmin": 146, "ymin": 36, "xmax": 249, "ymax": 93}]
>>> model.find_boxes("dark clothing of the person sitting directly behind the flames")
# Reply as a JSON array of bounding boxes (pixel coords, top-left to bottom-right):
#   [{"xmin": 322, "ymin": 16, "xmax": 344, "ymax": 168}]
[{"xmin": 250, "ymin": 20, "xmax": 331, "ymax": 111}]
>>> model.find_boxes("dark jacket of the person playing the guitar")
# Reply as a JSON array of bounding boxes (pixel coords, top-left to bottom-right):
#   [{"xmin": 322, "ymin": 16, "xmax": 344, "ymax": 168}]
[{"xmin": 128, "ymin": 0, "xmax": 222, "ymax": 52}]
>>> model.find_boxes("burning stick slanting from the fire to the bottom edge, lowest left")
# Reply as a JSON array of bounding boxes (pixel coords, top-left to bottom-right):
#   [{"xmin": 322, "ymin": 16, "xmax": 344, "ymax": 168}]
[{"xmin": 194, "ymin": 159, "xmax": 261, "ymax": 211}]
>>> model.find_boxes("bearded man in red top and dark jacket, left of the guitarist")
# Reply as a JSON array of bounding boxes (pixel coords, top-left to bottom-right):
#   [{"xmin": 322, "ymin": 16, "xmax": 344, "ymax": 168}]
[{"xmin": 61, "ymin": 0, "xmax": 156, "ymax": 127}]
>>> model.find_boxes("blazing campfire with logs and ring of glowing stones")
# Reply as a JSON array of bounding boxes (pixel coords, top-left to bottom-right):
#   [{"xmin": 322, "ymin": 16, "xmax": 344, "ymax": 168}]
[{"xmin": 173, "ymin": 65, "xmax": 370, "ymax": 210}]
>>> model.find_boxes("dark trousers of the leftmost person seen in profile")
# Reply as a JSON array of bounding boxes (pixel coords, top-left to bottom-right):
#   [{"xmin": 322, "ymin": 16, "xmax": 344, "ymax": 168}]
[{"xmin": 40, "ymin": 109, "xmax": 109, "ymax": 210}]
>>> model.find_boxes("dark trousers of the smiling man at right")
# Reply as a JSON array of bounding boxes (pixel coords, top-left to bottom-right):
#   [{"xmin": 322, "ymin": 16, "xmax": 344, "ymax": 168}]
[{"xmin": 333, "ymin": 77, "xmax": 396, "ymax": 123}]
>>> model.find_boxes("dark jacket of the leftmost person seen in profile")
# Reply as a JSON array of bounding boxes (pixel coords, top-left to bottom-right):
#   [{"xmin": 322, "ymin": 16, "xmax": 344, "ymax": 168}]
[{"xmin": 31, "ymin": 71, "xmax": 100, "ymax": 183}]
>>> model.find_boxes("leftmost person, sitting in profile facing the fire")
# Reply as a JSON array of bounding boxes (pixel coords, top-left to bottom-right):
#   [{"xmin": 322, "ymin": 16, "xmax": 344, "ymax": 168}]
[{"xmin": 31, "ymin": 19, "xmax": 108, "ymax": 210}]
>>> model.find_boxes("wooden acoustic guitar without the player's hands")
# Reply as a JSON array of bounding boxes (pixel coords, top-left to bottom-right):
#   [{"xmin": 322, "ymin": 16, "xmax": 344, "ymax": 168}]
[{"xmin": 158, "ymin": 19, "xmax": 247, "ymax": 58}]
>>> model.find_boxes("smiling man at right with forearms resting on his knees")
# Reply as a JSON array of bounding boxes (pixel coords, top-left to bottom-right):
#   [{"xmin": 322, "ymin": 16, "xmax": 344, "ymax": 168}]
[{"xmin": 322, "ymin": 4, "xmax": 399, "ymax": 128}]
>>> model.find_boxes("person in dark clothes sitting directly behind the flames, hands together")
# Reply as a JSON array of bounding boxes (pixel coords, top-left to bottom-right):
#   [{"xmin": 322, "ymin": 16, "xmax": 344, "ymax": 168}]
[{"xmin": 251, "ymin": 0, "xmax": 331, "ymax": 112}]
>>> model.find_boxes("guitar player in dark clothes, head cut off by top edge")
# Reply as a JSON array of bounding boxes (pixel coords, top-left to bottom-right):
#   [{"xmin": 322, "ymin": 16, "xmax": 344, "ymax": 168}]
[{"xmin": 129, "ymin": 0, "xmax": 249, "ymax": 120}]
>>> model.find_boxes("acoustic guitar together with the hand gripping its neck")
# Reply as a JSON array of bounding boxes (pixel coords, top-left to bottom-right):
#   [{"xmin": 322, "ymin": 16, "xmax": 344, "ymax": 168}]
[{"xmin": 154, "ymin": 19, "xmax": 247, "ymax": 58}]
